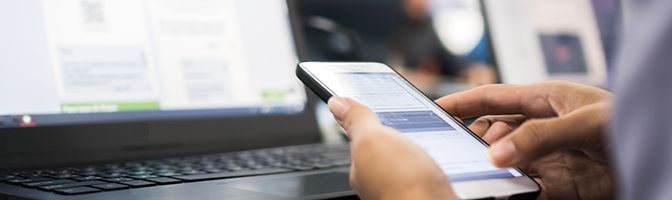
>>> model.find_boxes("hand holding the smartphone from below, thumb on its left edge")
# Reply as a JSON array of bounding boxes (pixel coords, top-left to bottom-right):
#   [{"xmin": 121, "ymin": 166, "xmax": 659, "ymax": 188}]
[{"xmin": 329, "ymin": 97, "xmax": 457, "ymax": 199}]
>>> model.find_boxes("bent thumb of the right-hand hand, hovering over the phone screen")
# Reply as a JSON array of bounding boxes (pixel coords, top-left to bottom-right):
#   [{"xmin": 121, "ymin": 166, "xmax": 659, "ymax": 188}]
[{"xmin": 490, "ymin": 103, "xmax": 609, "ymax": 167}]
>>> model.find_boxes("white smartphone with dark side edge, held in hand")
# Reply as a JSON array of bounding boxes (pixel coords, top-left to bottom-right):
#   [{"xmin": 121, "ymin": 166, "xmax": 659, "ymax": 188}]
[{"xmin": 296, "ymin": 62, "xmax": 541, "ymax": 199}]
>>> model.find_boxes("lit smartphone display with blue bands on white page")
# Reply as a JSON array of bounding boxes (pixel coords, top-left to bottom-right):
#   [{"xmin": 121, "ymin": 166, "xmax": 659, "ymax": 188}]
[{"xmin": 308, "ymin": 63, "xmax": 523, "ymax": 182}]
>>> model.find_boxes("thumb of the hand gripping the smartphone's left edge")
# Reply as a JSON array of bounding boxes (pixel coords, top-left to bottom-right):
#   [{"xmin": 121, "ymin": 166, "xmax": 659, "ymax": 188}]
[{"xmin": 328, "ymin": 96, "xmax": 382, "ymax": 139}]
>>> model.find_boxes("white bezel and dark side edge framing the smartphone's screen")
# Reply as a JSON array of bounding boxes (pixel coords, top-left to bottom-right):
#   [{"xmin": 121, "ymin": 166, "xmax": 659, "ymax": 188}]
[{"xmin": 296, "ymin": 62, "xmax": 541, "ymax": 199}]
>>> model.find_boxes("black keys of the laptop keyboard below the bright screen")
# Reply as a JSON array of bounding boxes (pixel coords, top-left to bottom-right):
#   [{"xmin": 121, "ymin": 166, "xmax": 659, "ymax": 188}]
[{"xmin": 0, "ymin": 144, "xmax": 350, "ymax": 195}]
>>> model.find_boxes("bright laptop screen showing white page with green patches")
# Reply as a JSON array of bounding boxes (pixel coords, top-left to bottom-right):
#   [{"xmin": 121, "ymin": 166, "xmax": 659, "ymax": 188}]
[{"xmin": 0, "ymin": 0, "xmax": 306, "ymax": 128}]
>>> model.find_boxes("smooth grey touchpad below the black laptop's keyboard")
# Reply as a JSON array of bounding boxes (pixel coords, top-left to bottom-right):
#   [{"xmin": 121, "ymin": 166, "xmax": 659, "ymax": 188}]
[{"xmin": 227, "ymin": 172, "xmax": 350, "ymax": 197}]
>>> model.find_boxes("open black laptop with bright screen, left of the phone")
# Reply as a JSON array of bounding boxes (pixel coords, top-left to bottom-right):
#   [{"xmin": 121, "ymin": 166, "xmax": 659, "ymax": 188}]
[{"xmin": 0, "ymin": 0, "xmax": 354, "ymax": 200}]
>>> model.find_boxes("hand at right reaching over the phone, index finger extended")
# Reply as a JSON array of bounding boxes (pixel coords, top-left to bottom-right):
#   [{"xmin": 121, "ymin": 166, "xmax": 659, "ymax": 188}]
[{"xmin": 437, "ymin": 81, "xmax": 614, "ymax": 199}]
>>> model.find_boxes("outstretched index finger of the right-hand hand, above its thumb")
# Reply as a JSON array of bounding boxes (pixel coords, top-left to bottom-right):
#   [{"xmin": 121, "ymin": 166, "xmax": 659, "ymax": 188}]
[{"xmin": 436, "ymin": 84, "xmax": 552, "ymax": 118}]
